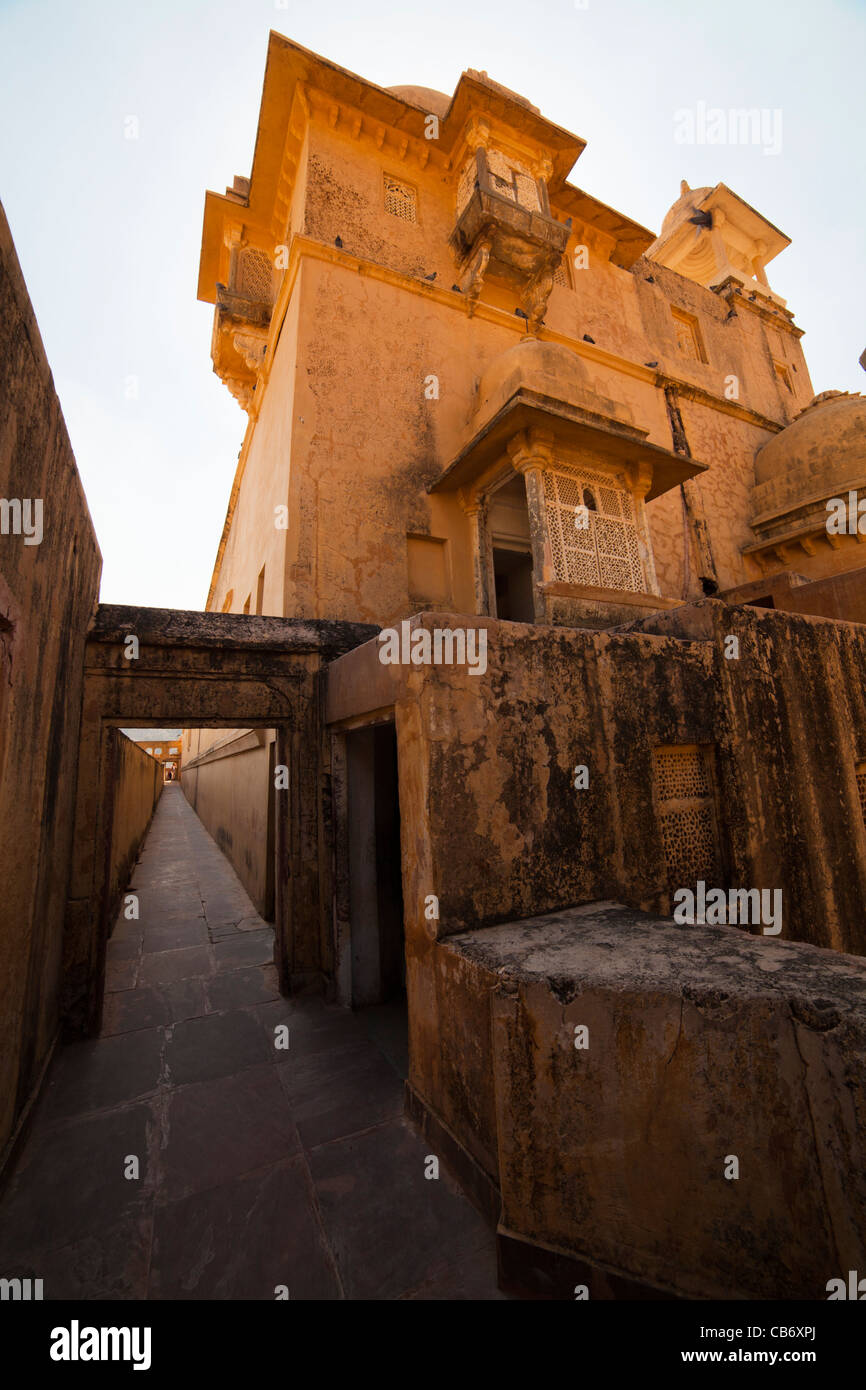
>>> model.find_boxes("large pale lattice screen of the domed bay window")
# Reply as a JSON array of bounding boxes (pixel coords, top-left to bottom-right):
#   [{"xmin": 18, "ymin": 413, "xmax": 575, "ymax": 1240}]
[{"xmin": 544, "ymin": 468, "xmax": 644, "ymax": 594}]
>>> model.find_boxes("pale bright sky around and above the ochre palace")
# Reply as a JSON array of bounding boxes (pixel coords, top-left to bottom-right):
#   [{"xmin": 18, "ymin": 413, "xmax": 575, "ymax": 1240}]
[{"xmin": 0, "ymin": 0, "xmax": 866, "ymax": 607}]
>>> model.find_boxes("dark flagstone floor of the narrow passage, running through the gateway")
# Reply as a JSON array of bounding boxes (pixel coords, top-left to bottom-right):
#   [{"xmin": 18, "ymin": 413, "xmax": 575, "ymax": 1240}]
[{"xmin": 0, "ymin": 783, "xmax": 503, "ymax": 1300}]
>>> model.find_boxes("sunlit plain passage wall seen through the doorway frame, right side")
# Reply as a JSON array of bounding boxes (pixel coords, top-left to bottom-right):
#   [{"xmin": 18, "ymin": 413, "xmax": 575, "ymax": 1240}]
[{"xmin": 181, "ymin": 730, "xmax": 274, "ymax": 922}]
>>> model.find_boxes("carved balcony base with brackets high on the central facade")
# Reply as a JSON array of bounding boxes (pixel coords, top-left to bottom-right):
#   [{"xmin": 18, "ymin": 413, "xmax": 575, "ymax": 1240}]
[{"xmin": 449, "ymin": 185, "xmax": 569, "ymax": 334}]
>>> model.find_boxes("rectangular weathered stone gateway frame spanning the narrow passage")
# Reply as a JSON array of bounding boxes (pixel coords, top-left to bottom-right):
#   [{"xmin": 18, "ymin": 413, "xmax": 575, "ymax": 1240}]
[{"xmin": 61, "ymin": 605, "xmax": 378, "ymax": 1036}]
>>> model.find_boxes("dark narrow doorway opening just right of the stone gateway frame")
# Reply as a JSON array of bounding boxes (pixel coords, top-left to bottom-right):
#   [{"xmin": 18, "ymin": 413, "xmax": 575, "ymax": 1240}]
[{"xmin": 346, "ymin": 723, "xmax": 406, "ymax": 1008}]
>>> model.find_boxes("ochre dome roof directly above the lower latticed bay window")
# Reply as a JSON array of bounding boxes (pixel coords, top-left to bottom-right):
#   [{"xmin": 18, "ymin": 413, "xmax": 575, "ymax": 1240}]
[{"xmin": 474, "ymin": 338, "xmax": 631, "ymax": 425}]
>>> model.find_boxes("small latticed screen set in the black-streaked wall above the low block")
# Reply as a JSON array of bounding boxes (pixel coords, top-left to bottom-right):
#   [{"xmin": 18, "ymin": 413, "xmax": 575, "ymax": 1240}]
[{"xmin": 653, "ymin": 746, "xmax": 720, "ymax": 891}]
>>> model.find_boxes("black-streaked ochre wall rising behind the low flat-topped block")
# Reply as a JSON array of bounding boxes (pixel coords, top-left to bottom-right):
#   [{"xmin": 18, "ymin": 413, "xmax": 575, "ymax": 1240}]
[{"xmin": 328, "ymin": 599, "xmax": 866, "ymax": 1172}]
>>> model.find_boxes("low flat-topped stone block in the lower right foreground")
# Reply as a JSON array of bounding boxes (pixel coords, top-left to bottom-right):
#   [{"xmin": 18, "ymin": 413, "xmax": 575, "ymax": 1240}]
[{"xmin": 436, "ymin": 904, "xmax": 866, "ymax": 1300}]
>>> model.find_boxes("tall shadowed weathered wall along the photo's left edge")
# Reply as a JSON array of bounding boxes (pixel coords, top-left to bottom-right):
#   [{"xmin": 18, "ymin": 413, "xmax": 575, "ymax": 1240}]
[{"xmin": 0, "ymin": 209, "xmax": 101, "ymax": 1162}]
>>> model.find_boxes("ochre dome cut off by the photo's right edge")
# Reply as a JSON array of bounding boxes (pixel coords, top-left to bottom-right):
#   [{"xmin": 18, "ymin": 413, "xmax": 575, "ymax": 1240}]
[{"xmin": 755, "ymin": 391, "xmax": 866, "ymax": 496}]
